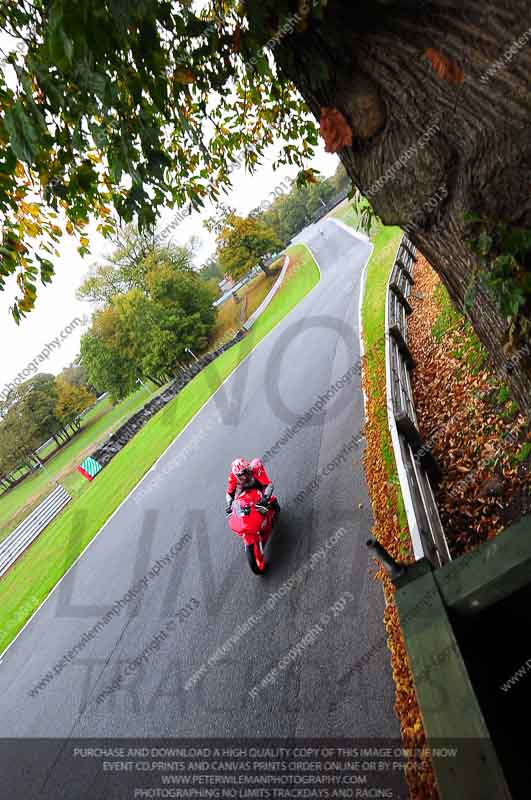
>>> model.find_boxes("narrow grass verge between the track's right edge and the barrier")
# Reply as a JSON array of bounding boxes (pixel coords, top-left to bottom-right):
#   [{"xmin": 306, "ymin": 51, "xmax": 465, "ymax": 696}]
[{"xmin": 362, "ymin": 224, "xmax": 407, "ymax": 548}]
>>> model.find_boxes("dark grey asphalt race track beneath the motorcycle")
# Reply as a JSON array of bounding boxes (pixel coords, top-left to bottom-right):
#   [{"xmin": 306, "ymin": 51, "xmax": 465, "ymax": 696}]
[{"xmin": 0, "ymin": 216, "xmax": 408, "ymax": 797}]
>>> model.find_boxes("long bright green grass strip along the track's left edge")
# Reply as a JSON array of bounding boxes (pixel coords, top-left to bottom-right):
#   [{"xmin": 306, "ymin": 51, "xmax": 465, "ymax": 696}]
[{"xmin": 0, "ymin": 245, "xmax": 319, "ymax": 652}]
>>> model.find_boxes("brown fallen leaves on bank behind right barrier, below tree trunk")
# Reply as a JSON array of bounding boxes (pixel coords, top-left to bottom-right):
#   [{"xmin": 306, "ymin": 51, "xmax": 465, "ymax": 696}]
[{"xmin": 408, "ymin": 255, "xmax": 531, "ymax": 557}]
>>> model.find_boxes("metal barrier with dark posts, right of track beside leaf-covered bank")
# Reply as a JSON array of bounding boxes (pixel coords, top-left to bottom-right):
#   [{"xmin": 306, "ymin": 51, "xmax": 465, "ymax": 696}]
[{"xmin": 385, "ymin": 236, "xmax": 451, "ymax": 567}]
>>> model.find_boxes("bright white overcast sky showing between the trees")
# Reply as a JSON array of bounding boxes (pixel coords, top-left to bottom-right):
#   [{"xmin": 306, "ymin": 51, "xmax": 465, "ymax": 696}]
[{"xmin": 0, "ymin": 145, "xmax": 339, "ymax": 396}]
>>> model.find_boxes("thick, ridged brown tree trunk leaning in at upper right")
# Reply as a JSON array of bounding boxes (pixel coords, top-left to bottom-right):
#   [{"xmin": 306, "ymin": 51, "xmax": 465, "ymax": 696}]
[{"xmin": 260, "ymin": 0, "xmax": 531, "ymax": 417}]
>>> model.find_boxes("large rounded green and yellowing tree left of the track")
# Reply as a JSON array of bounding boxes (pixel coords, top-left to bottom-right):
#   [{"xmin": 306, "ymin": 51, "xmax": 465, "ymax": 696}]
[{"xmin": 78, "ymin": 226, "xmax": 216, "ymax": 402}]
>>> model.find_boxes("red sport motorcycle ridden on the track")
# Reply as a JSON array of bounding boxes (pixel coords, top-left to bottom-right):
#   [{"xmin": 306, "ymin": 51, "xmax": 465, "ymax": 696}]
[{"xmin": 229, "ymin": 489, "xmax": 280, "ymax": 575}]
